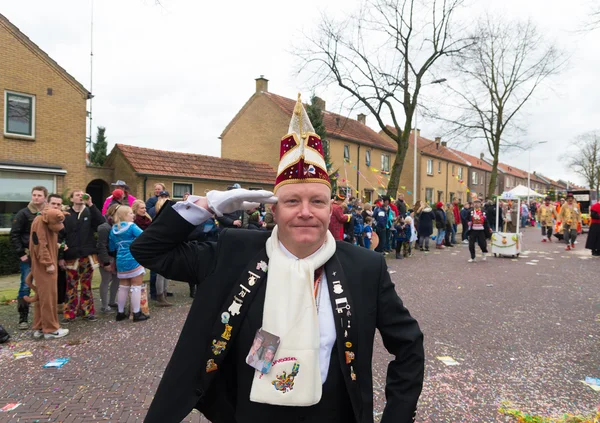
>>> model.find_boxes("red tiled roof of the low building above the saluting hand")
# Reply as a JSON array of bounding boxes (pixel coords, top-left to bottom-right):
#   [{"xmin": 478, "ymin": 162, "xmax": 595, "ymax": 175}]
[{"xmin": 115, "ymin": 144, "xmax": 276, "ymax": 185}]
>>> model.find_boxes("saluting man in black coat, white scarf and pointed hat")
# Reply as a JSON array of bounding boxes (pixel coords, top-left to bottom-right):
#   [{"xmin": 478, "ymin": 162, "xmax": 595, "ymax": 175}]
[{"xmin": 131, "ymin": 96, "xmax": 424, "ymax": 423}]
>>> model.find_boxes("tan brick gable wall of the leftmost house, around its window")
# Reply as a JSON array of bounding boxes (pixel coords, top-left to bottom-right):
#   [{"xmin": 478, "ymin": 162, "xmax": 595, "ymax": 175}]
[{"xmin": 0, "ymin": 25, "xmax": 86, "ymax": 191}]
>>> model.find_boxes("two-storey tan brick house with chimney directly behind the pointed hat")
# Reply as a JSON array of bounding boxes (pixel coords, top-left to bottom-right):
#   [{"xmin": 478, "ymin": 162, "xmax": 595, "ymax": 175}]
[{"xmin": 221, "ymin": 76, "xmax": 398, "ymax": 202}]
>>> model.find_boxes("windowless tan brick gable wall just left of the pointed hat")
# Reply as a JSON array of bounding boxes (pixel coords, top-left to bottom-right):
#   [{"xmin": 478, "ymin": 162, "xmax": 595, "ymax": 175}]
[{"xmin": 221, "ymin": 94, "xmax": 291, "ymax": 169}]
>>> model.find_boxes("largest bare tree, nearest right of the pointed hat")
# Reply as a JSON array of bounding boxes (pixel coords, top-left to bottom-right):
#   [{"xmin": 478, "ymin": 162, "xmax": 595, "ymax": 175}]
[{"xmin": 295, "ymin": 0, "xmax": 473, "ymax": 198}]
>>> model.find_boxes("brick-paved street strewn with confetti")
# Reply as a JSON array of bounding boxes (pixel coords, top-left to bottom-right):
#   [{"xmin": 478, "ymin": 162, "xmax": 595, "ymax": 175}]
[{"xmin": 0, "ymin": 228, "xmax": 600, "ymax": 422}]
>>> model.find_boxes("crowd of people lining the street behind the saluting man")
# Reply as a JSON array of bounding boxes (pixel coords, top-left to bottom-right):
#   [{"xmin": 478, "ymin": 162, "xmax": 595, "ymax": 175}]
[{"xmin": 4, "ymin": 176, "xmax": 600, "ymax": 339}]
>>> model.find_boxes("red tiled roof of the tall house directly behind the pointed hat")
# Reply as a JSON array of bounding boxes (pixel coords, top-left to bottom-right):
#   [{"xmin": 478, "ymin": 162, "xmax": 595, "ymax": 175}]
[{"xmin": 263, "ymin": 92, "xmax": 397, "ymax": 152}]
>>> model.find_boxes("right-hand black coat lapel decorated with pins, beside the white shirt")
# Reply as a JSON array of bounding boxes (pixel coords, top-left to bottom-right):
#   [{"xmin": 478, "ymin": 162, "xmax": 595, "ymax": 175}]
[{"xmin": 325, "ymin": 255, "xmax": 362, "ymax": 419}]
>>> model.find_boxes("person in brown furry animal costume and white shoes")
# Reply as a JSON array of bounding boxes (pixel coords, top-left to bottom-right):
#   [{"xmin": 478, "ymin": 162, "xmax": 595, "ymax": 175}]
[{"xmin": 24, "ymin": 208, "xmax": 69, "ymax": 339}]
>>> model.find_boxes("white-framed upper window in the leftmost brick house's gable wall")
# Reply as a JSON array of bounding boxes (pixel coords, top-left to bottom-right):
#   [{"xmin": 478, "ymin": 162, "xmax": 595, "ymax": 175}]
[{"xmin": 4, "ymin": 91, "xmax": 35, "ymax": 138}]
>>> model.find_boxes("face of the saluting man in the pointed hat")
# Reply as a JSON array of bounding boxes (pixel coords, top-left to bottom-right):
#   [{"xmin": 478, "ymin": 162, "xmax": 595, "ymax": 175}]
[{"xmin": 273, "ymin": 183, "xmax": 331, "ymax": 255}]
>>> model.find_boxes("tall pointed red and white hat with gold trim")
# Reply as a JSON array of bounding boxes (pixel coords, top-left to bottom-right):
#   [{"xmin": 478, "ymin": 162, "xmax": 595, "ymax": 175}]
[{"xmin": 273, "ymin": 94, "xmax": 331, "ymax": 192}]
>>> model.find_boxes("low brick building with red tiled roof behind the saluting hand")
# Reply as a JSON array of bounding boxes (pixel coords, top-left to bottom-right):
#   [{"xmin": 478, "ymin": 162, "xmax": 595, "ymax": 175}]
[{"xmin": 105, "ymin": 144, "xmax": 276, "ymax": 200}]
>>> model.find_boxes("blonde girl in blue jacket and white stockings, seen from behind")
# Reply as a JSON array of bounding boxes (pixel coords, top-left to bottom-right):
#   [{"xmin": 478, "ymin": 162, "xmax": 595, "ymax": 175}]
[{"xmin": 109, "ymin": 206, "xmax": 150, "ymax": 322}]
